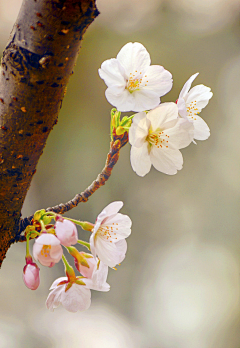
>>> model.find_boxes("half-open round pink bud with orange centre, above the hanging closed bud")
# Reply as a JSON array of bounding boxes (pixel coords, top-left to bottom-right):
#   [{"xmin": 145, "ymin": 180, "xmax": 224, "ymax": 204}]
[{"xmin": 33, "ymin": 233, "xmax": 63, "ymax": 267}]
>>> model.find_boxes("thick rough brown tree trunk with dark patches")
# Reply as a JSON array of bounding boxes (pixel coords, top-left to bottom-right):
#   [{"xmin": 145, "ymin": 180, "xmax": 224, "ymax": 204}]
[{"xmin": 0, "ymin": 0, "xmax": 98, "ymax": 266}]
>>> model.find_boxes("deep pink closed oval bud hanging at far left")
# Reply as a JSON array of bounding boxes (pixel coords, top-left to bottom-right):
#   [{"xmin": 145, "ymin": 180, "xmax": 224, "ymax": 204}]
[{"xmin": 23, "ymin": 256, "xmax": 40, "ymax": 290}]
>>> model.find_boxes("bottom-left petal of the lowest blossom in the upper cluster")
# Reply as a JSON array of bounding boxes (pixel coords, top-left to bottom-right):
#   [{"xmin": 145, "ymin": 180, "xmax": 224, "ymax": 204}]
[{"xmin": 130, "ymin": 141, "xmax": 151, "ymax": 176}]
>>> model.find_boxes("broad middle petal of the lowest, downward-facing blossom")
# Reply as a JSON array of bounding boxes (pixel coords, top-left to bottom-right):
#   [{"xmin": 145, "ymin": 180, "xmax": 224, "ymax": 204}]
[{"xmin": 61, "ymin": 283, "xmax": 91, "ymax": 313}]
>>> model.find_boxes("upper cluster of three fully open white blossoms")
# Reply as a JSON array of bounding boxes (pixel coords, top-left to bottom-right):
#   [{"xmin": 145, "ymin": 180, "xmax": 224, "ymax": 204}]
[{"xmin": 99, "ymin": 42, "xmax": 213, "ymax": 176}]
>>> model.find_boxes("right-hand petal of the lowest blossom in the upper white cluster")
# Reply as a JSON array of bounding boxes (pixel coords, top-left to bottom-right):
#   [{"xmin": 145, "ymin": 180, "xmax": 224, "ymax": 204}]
[{"xmin": 161, "ymin": 118, "xmax": 194, "ymax": 149}]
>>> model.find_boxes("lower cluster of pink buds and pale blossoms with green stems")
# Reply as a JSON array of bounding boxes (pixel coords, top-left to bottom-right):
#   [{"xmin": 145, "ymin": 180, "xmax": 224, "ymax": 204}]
[{"xmin": 23, "ymin": 202, "xmax": 132, "ymax": 312}]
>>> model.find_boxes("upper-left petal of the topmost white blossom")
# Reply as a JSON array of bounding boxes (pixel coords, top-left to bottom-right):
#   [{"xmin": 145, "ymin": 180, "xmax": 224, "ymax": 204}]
[{"xmin": 98, "ymin": 58, "xmax": 127, "ymax": 88}]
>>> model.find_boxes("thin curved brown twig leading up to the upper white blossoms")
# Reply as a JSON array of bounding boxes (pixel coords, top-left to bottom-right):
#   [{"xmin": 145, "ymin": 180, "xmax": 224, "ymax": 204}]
[{"xmin": 15, "ymin": 132, "xmax": 128, "ymax": 241}]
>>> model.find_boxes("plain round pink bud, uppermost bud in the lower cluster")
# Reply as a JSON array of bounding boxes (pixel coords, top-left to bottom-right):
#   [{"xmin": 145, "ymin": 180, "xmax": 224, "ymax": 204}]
[{"xmin": 55, "ymin": 219, "xmax": 78, "ymax": 247}]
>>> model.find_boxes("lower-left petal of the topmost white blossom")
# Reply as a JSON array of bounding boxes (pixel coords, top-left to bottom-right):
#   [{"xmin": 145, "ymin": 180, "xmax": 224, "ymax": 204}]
[{"xmin": 105, "ymin": 87, "xmax": 135, "ymax": 112}]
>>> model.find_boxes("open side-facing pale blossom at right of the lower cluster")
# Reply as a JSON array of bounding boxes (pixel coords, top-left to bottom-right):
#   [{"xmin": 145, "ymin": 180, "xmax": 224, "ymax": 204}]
[{"xmin": 90, "ymin": 202, "xmax": 132, "ymax": 267}]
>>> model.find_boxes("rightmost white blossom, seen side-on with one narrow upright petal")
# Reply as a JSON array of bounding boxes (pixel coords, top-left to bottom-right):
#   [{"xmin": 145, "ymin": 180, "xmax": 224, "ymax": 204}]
[{"xmin": 177, "ymin": 73, "xmax": 213, "ymax": 140}]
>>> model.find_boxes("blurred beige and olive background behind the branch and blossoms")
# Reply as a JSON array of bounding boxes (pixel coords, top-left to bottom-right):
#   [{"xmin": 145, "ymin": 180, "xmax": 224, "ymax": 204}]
[{"xmin": 0, "ymin": 0, "xmax": 240, "ymax": 348}]
